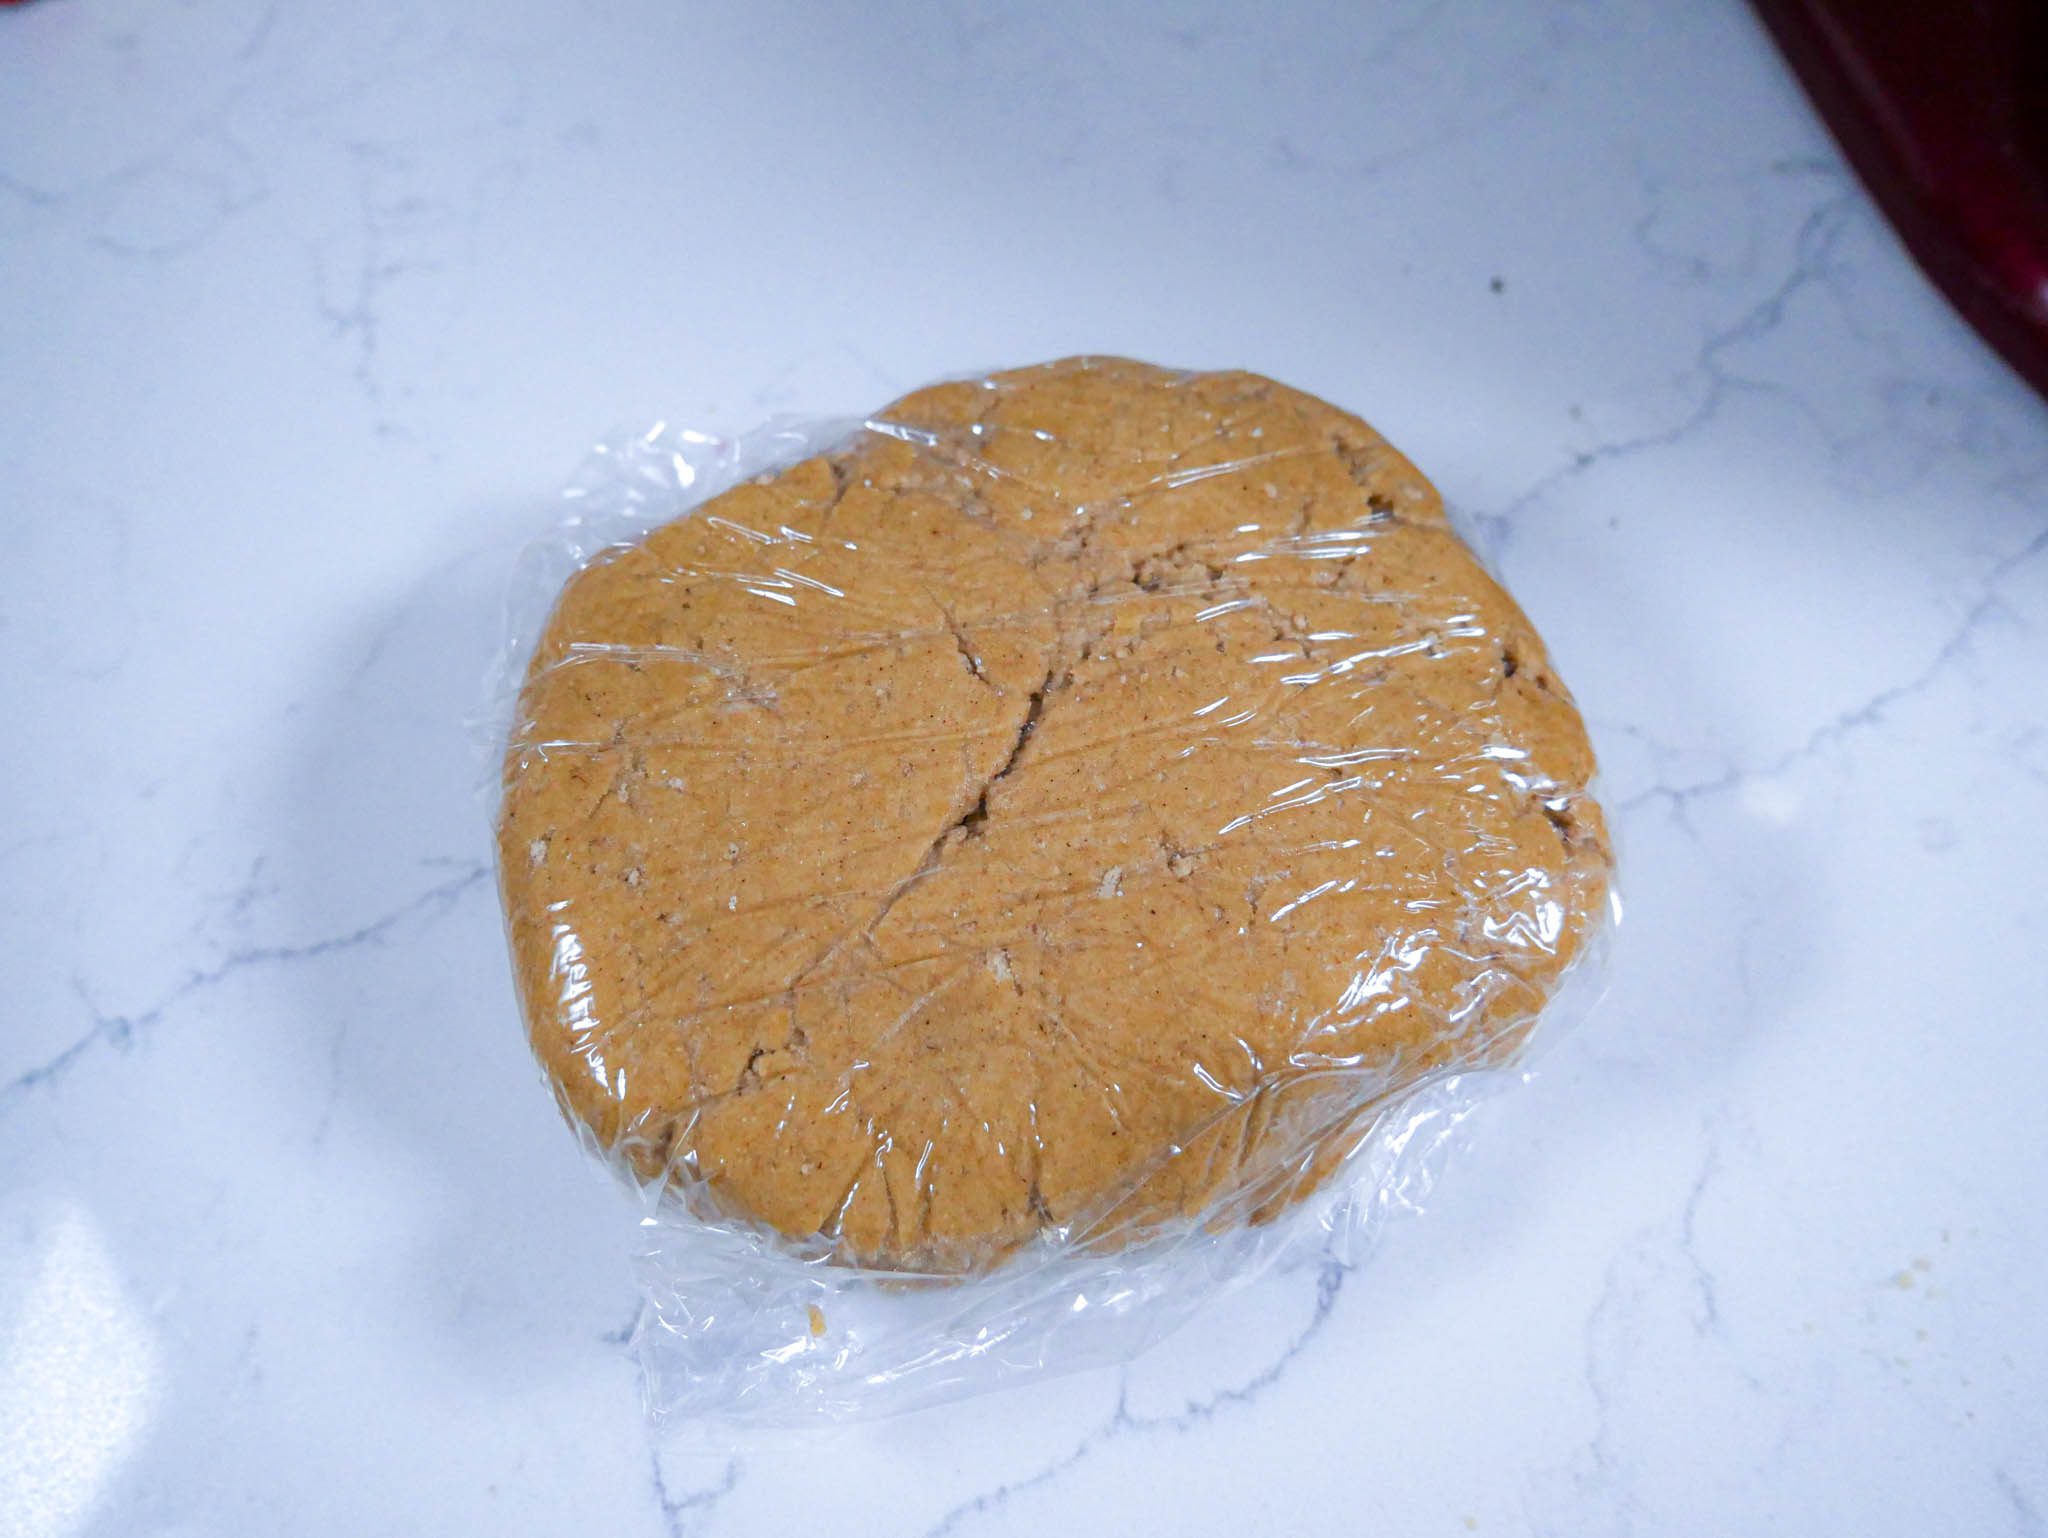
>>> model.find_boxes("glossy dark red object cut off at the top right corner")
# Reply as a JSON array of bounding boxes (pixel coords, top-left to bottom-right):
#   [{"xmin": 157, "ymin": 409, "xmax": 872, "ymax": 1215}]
[{"xmin": 1755, "ymin": 0, "xmax": 2048, "ymax": 395}]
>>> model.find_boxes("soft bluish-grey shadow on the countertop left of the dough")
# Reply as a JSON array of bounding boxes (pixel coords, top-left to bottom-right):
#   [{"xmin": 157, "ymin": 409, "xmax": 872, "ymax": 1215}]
[{"xmin": 274, "ymin": 516, "xmax": 633, "ymax": 1384}]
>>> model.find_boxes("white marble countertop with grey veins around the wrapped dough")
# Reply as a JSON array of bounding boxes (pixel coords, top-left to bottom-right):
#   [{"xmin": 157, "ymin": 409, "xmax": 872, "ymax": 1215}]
[{"xmin": 0, "ymin": 0, "xmax": 2048, "ymax": 1538}]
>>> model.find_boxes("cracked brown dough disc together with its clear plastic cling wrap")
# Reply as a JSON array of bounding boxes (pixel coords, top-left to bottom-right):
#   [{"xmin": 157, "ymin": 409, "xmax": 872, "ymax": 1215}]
[{"xmin": 498, "ymin": 358, "xmax": 1612, "ymax": 1419}]
